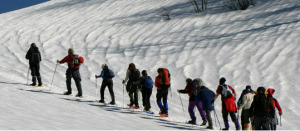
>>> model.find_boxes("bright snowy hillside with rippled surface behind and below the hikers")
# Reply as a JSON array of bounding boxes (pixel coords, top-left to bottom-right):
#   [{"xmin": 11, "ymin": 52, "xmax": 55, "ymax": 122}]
[{"xmin": 0, "ymin": 0, "xmax": 300, "ymax": 130}]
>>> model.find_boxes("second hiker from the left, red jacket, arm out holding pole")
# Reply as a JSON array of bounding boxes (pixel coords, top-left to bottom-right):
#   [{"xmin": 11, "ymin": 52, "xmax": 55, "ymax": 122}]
[{"xmin": 57, "ymin": 48, "xmax": 84, "ymax": 97}]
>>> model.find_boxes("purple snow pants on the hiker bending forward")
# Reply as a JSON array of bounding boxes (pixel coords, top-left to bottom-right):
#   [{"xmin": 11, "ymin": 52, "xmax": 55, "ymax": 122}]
[{"xmin": 188, "ymin": 101, "xmax": 206, "ymax": 121}]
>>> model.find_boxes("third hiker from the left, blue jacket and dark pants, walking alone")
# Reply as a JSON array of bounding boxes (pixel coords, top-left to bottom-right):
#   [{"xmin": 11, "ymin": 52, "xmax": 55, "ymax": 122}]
[{"xmin": 95, "ymin": 64, "xmax": 116, "ymax": 105}]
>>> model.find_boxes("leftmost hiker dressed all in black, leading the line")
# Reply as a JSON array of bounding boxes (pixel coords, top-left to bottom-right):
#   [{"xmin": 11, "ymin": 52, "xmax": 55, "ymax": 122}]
[{"xmin": 25, "ymin": 43, "xmax": 42, "ymax": 86}]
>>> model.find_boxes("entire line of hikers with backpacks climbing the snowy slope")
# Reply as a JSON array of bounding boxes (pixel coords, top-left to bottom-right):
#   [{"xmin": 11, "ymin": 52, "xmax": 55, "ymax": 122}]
[{"xmin": 26, "ymin": 43, "xmax": 282, "ymax": 130}]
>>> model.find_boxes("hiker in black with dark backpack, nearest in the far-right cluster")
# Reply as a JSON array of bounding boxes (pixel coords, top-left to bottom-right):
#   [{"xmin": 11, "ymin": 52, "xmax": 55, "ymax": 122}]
[{"xmin": 250, "ymin": 87, "xmax": 275, "ymax": 130}]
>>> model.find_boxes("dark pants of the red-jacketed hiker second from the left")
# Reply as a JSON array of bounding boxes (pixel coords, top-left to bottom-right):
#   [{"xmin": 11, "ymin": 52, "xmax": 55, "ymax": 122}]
[{"xmin": 66, "ymin": 68, "xmax": 82, "ymax": 96}]
